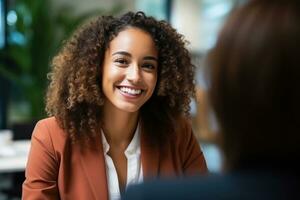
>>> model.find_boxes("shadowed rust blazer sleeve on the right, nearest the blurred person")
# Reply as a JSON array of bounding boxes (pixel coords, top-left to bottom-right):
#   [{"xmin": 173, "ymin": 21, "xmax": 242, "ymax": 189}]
[{"xmin": 179, "ymin": 121, "xmax": 208, "ymax": 175}]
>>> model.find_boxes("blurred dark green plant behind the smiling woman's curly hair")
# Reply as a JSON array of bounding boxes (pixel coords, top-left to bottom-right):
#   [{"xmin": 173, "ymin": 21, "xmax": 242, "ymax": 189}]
[{"xmin": 0, "ymin": 0, "xmax": 122, "ymax": 120}]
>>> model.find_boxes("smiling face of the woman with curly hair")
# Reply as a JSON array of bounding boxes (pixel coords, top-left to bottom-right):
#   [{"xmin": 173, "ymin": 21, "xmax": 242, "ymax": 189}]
[{"xmin": 102, "ymin": 28, "xmax": 158, "ymax": 112}]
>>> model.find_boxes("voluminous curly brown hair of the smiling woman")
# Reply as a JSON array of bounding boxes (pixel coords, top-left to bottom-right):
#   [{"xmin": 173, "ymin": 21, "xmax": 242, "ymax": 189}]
[{"xmin": 46, "ymin": 12, "xmax": 195, "ymax": 144}]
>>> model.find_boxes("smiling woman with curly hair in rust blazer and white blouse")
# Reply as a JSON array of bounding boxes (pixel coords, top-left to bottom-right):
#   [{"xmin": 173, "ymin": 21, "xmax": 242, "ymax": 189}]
[{"xmin": 23, "ymin": 12, "xmax": 207, "ymax": 199}]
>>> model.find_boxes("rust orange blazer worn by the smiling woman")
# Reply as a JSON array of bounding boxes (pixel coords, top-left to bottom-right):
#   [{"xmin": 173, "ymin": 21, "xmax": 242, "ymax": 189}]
[{"xmin": 22, "ymin": 117, "xmax": 207, "ymax": 200}]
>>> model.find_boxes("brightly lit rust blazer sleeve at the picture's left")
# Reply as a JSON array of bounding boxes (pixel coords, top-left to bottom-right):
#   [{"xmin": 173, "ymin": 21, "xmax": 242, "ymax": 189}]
[{"xmin": 22, "ymin": 121, "xmax": 59, "ymax": 200}]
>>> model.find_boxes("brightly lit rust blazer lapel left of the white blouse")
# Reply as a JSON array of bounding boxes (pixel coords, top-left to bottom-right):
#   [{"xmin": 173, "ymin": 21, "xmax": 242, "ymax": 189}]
[{"xmin": 80, "ymin": 137, "xmax": 108, "ymax": 200}]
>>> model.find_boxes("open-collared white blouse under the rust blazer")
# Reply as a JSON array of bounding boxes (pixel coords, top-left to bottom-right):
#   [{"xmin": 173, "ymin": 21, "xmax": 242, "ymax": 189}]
[{"xmin": 102, "ymin": 126, "xmax": 143, "ymax": 200}]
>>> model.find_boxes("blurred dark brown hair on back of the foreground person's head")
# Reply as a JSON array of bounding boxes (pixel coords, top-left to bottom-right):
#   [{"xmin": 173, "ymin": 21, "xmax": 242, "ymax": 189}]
[{"xmin": 208, "ymin": 0, "xmax": 300, "ymax": 168}]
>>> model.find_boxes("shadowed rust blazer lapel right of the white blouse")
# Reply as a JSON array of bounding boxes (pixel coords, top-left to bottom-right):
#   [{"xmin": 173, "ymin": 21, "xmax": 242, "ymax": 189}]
[{"xmin": 141, "ymin": 128, "xmax": 159, "ymax": 179}]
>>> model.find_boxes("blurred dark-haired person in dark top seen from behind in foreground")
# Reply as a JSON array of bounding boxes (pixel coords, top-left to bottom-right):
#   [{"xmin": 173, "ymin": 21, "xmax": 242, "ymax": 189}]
[{"xmin": 125, "ymin": 0, "xmax": 300, "ymax": 200}]
